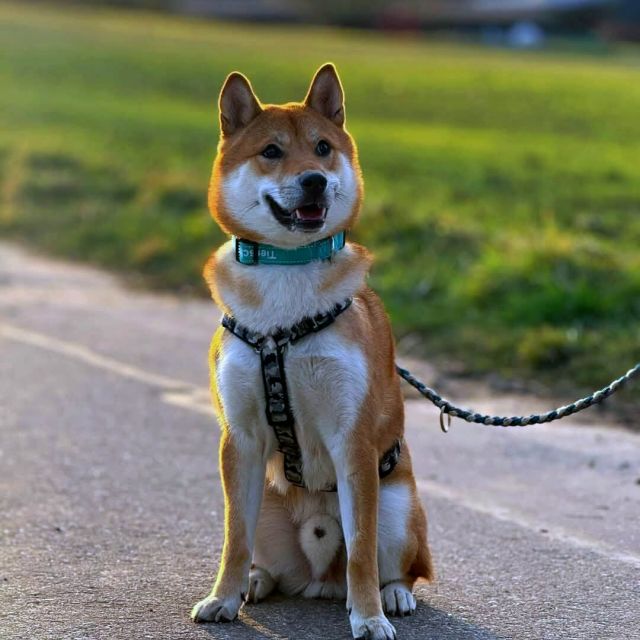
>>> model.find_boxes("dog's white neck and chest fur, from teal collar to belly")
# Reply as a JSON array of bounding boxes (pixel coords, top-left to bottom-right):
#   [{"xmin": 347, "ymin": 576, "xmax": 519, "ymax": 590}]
[{"xmin": 215, "ymin": 242, "xmax": 369, "ymax": 489}]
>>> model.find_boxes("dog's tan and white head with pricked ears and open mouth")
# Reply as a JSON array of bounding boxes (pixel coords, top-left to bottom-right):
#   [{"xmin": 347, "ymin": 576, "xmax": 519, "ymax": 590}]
[{"xmin": 209, "ymin": 64, "xmax": 362, "ymax": 247}]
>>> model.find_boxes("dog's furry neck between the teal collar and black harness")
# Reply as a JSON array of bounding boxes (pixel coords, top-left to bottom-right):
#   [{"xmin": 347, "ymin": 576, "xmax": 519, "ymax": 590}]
[{"xmin": 204, "ymin": 240, "xmax": 371, "ymax": 334}]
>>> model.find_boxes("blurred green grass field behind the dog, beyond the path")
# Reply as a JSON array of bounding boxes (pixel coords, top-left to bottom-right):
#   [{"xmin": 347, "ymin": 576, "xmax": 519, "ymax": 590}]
[{"xmin": 0, "ymin": 4, "xmax": 640, "ymax": 400}]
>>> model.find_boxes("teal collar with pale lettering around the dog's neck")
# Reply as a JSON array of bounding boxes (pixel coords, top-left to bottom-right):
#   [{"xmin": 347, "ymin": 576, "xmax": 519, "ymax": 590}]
[{"xmin": 233, "ymin": 231, "xmax": 347, "ymax": 264}]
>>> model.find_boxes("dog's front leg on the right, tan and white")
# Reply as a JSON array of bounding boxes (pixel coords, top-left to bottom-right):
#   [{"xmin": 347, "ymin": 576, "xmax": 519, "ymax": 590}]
[{"xmin": 335, "ymin": 447, "xmax": 396, "ymax": 640}]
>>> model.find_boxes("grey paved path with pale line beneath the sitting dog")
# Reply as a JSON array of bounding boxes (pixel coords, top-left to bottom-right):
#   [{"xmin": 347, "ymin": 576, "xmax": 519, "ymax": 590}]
[{"xmin": 0, "ymin": 244, "xmax": 640, "ymax": 640}]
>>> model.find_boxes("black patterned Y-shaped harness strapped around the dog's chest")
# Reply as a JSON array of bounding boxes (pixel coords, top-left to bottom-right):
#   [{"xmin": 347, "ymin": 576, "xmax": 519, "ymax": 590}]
[{"xmin": 222, "ymin": 298, "xmax": 401, "ymax": 491}]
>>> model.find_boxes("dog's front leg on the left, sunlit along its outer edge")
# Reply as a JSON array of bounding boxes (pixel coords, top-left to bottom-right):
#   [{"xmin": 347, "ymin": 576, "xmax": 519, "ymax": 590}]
[{"xmin": 191, "ymin": 429, "xmax": 266, "ymax": 622}]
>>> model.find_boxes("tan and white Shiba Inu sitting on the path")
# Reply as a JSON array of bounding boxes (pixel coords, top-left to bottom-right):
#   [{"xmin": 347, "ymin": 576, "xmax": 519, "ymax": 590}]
[{"xmin": 192, "ymin": 64, "xmax": 434, "ymax": 640}]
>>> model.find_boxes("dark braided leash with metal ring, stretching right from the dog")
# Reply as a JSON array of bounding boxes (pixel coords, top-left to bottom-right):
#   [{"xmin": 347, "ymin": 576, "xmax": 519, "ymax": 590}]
[{"xmin": 396, "ymin": 363, "xmax": 640, "ymax": 433}]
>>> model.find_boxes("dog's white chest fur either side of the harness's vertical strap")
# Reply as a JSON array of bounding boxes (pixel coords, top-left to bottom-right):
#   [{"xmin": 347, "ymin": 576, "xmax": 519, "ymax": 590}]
[{"xmin": 216, "ymin": 327, "xmax": 368, "ymax": 491}]
